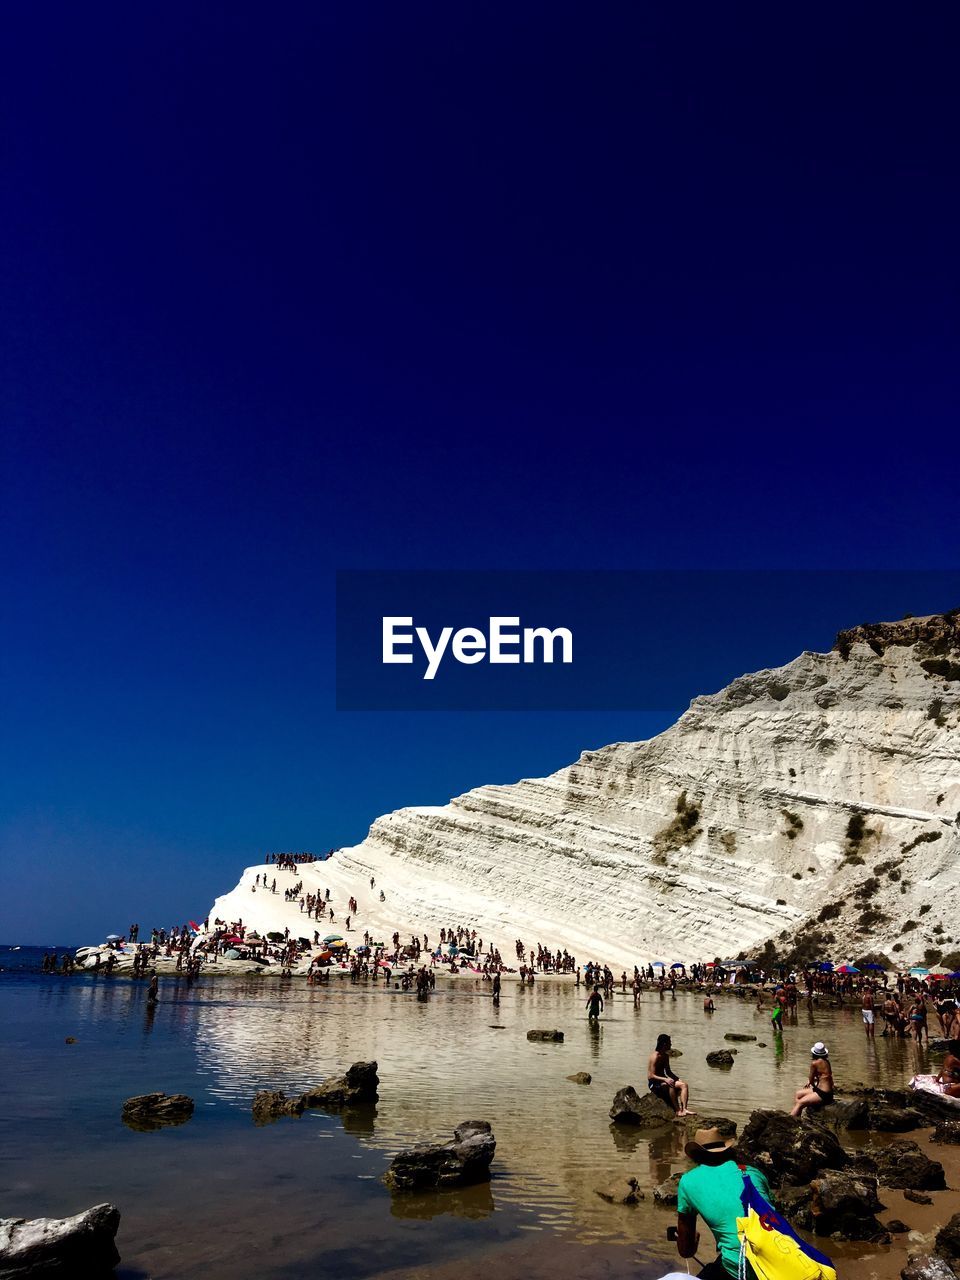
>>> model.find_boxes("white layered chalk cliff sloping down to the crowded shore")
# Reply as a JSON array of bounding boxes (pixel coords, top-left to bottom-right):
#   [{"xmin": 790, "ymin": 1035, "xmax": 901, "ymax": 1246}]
[{"xmin": 211, "ymin": 613, "xmax": 960, "ymax": 966}]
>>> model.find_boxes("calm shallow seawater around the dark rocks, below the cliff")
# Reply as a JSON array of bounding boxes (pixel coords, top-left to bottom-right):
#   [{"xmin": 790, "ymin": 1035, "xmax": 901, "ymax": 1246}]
[{"xmin": 0, "ymin": 947, "xmax": 947, "ymax": 1280}]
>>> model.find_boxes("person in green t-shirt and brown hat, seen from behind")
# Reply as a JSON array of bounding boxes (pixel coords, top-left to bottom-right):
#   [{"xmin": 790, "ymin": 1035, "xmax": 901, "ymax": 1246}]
[{"xmin": 677, "ymin": 1129, "xmax": 771, "ymax": 1280}]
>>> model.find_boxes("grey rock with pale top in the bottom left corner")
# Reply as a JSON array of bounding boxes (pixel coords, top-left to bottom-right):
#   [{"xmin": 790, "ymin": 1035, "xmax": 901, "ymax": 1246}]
[{"xmin": 0, "ymin": 1204, "xmax": 120, "ymax": 1280}]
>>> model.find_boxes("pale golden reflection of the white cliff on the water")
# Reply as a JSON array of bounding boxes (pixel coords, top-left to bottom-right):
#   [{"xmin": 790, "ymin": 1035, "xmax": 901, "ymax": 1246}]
[{"xmin": 184, "ymin": 979, "xmax": 926, "ymax": 1240}]
